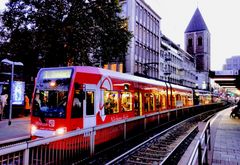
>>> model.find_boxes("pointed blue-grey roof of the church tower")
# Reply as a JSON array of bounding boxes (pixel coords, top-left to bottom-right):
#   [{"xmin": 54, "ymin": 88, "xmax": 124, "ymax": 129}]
[{"xmin": 185, "ymin": 8, "xmax": 208, "ymax": 33}]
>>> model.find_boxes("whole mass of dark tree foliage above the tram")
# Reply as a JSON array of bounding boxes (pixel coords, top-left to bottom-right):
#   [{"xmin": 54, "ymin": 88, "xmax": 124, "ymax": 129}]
[{"xmin": 0, "ymin": 0, "xmax": 132, "ymax": 80}]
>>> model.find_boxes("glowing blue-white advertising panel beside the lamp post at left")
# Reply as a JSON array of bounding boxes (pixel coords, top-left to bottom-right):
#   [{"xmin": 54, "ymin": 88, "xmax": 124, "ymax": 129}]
[{"xmin": 12, "ymin": 81, "xmax": 25, "ymax": 105}]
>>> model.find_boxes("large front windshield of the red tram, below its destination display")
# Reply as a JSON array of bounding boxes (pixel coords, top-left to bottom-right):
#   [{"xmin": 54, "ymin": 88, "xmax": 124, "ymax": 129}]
[{"xmin": 32, "ymin": 79, "xmax": 70, "ymax": 118}]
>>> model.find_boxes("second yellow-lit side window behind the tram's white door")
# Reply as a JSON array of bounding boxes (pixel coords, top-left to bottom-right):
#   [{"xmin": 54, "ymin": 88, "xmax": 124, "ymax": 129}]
[{"xmin": 121, "ymin": 92, "xmax": 132, "ymax": 111}]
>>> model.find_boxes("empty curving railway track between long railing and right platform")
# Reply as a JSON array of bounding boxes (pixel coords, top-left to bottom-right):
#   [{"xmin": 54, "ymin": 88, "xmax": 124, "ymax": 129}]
[{"xmin": 107, "ymin": 112, "xmax": 213, "ymax": 165}]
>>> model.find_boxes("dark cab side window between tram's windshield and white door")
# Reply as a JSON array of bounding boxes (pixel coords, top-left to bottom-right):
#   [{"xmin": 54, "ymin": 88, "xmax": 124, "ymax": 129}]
[{"xmin": 71, "ymin": 91, "xmax": 84, "ymax": 118}]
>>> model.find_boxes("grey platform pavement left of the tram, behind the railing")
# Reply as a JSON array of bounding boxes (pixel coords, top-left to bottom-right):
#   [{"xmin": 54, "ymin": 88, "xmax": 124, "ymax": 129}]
[{"xmin": 0, "ymin": 117, "xmax": 30, "ymax": 144}]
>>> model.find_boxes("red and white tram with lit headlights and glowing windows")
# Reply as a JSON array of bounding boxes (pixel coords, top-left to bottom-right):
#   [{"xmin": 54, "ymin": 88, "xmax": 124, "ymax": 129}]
[{"xmin": 31, "ymin": 66, "xmax": 193, "ymax": 137}]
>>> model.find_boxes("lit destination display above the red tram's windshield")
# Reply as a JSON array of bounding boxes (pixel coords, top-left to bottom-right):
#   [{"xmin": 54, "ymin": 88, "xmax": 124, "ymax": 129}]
[{"xmin": 40, "ymin": 69, "xmax": 72, "ymax": 79}]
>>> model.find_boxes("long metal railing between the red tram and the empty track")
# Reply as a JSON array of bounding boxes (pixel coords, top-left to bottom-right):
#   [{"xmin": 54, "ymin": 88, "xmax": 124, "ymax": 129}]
[{"xmin": 0, "ymin": 103, "xmax": 223, "ymax": 165}]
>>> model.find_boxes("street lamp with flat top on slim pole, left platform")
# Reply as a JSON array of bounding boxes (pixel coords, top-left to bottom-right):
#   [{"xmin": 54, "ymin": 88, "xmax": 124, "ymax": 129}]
[{"xmin": 1, "ymin": 59, "xmax": 23, "ymax": 125}]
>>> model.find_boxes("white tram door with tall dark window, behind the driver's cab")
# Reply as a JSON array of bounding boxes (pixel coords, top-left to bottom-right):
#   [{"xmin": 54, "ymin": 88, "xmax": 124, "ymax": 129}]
[{"xmin": 83, "ymin": 84, "xmax": 97, "ymax": 128}]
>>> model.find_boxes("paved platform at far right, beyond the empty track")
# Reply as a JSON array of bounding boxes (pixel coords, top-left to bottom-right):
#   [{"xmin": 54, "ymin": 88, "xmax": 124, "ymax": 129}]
[{"xmin": 209, "ymin": 107, "xmax": 240, "ymax": 165}]
